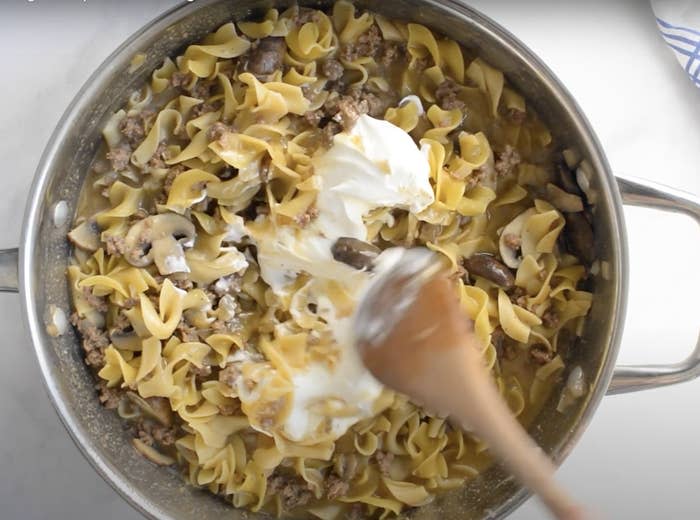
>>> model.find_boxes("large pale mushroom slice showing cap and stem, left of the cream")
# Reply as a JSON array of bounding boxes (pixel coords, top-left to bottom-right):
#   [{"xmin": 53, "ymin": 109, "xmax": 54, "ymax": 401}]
[{"xmin": 124, "ymin": 213, "xmax": 195, "ymax": 275}]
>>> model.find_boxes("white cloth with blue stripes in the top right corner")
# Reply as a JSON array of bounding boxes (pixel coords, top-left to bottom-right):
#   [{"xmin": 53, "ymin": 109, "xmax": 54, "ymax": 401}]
[{"xmin": 651, "ymin": 0, "xmax": 700, "ymax": 87}]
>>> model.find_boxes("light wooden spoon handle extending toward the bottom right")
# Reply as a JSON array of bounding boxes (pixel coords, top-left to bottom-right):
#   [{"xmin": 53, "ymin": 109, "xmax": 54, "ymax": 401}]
[{"xmin": 453, "ymin": 340, "xmax": 586, "ymax": 520}]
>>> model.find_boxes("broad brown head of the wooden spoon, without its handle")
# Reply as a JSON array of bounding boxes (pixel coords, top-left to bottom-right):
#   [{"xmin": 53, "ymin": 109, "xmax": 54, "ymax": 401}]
[{"xmin": 357, "ymin": 250, "xmax": 479, "ymax": 413}]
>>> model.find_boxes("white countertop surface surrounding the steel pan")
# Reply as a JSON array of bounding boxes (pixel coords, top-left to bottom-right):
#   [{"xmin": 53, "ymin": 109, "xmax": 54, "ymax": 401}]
[{"xmin": 0, "ymin": 0, "xmax": 700, "ymax": 520}]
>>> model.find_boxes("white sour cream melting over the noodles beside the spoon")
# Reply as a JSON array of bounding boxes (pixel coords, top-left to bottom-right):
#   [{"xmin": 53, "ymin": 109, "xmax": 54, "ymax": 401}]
[{"xmin": 249, "ymin": 115, "xmax": 434, "ymax": 441}]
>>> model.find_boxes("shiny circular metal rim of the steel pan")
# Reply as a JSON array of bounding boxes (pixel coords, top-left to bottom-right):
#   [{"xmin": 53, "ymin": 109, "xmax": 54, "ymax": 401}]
[{"xmin": 19, "ymin": 0, "xmax": 629, "ymax": 519}]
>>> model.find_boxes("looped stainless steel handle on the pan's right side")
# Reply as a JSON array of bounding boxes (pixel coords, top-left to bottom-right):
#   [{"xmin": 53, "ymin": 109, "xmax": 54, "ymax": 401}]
[{"xmin": 607, "ymin": 177, "xmax": 700, "ymax": 394}]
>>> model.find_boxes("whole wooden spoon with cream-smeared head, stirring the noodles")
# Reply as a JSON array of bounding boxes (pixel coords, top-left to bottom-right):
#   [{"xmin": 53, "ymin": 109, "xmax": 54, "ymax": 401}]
[{"xmin": 356, "ymin": 248, "xmax": 587, "ymax": 520}]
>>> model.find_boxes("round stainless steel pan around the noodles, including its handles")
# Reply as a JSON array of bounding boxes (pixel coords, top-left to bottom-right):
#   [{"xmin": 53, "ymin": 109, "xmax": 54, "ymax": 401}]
[{"xmin": 0, "ymin": 0, "xmax": 700, "ymax": 519}]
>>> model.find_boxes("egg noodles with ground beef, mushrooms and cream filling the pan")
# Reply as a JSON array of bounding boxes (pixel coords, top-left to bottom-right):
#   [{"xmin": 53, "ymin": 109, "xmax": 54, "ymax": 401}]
[{"xmin": 68, "ymin": 1, "xmax": 594, "ymax": 519}]
